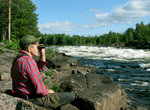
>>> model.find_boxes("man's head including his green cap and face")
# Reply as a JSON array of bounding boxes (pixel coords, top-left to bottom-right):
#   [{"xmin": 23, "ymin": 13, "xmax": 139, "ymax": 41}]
[{"xmin": 20, "ymin": 35, "xmax": 39, "ymax": 57}]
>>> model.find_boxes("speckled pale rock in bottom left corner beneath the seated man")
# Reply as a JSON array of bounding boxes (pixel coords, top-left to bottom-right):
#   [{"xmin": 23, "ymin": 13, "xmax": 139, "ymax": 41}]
[{"xmin": 0, "ymin": 93, "xmax": 46, "ymax": 110}]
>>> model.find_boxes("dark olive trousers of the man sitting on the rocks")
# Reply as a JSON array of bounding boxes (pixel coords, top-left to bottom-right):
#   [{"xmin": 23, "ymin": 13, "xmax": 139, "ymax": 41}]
[{"xmin": 29, "ymin": 92, "xmax": 75, "ymax": 110}]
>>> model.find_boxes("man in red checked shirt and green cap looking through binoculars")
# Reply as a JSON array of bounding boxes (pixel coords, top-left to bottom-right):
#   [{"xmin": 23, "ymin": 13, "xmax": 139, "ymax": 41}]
[{"xmin": 11, "ymin": 35, "xmax": 75, "ymax": 109}]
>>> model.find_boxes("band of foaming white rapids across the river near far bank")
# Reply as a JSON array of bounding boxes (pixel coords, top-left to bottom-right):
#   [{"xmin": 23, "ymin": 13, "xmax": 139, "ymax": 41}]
[{"xmin": 55, "ymin": 46, "xmax": 150, "ymax": 67}]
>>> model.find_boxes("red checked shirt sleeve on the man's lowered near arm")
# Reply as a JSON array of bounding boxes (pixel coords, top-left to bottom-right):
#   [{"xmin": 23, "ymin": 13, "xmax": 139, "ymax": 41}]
[{"xmin": 26, "ymin": 59, "xmax": 48, "ymax": 96}]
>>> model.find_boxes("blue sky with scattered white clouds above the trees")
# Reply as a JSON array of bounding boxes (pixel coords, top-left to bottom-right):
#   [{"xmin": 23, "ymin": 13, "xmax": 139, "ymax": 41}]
[{"xmin": 32, "ymin": 0, "xmax": 150, "ymax": 36}]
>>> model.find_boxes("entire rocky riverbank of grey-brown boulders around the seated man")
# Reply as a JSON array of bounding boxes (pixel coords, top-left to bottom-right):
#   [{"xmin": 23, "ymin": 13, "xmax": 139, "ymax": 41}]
[{"xmin": 0, "ymin": 49, "xmax": 129, "ymax": 110}]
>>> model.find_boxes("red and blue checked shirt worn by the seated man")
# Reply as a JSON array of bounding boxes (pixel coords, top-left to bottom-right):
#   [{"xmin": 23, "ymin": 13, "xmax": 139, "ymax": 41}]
[{"xmin": 11, "ymin": 50, "xmax": 48, "ymax": 97}]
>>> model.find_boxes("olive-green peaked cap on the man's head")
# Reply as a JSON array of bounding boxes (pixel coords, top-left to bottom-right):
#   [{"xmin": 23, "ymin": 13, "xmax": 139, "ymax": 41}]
[{"xmin": 20, "ymin": 35, "xmax": 40, "ymax": 50}]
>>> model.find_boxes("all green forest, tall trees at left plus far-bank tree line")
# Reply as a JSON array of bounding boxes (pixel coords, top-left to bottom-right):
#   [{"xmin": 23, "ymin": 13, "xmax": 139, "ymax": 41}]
[{"xmin": 0, "ymin": 0, "xmax": 150, "ymax": 48}]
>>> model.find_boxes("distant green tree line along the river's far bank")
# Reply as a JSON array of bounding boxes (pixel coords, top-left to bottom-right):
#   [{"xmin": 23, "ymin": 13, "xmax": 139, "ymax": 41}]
[{"xmin": 41, "ymin": 22, "xmax": 150, "ymax": 45}]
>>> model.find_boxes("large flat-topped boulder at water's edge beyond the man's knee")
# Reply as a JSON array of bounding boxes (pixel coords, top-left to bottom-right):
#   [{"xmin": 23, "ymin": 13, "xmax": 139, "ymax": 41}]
[{"xmin": 61, "ymin": 74, "xmax": 127, "ymax": 110}]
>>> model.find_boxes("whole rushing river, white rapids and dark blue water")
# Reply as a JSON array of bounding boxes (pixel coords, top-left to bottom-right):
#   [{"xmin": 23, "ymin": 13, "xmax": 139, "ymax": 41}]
[{"xmin": 53, "ymin": 46, "xmax": 150, "ymax": 108}]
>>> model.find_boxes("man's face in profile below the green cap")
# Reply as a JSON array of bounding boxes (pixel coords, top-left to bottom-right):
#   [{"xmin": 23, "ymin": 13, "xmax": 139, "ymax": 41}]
[{"xmin": 29, "ymin": 42, "xmax": 39, "ymax": 57}]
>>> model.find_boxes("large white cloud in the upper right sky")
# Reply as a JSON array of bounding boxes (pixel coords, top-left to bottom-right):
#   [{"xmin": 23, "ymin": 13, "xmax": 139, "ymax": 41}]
[{"xmin": 96, "ymin": 0, "xmax": 150, "ymax": 23}]
